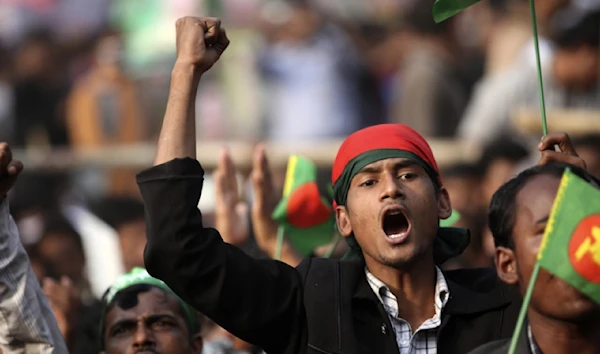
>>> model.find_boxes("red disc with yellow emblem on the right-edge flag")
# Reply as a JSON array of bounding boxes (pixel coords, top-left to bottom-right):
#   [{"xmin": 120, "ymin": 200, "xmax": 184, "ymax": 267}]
[{"xmin": 569, "ymin": 214, "xmax": 600, "ymax": 284}]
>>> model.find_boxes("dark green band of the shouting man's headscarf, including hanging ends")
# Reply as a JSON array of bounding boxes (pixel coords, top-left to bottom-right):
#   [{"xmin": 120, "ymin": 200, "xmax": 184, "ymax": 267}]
[{"xmin": 333, "ymin": 149, "xmax": 470, "ymax": 265}]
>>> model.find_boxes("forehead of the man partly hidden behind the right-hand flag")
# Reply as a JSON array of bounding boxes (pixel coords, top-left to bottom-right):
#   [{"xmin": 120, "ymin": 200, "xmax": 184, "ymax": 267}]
[{"xmin": 515, "ymin": 175, "xmax": 560, "ymax": 225}]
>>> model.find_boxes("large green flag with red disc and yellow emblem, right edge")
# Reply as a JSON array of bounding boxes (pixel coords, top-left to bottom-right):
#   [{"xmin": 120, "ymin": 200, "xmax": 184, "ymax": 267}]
[{"xmin": 538, "ymin": 169, "xmax": 600, "ymax": 303}]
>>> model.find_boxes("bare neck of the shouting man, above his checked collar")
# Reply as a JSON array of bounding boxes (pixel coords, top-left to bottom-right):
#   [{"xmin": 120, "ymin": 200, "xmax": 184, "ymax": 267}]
[{"xmin": 365, "ymin": 256, "xmax": 437, "ymax": 330}]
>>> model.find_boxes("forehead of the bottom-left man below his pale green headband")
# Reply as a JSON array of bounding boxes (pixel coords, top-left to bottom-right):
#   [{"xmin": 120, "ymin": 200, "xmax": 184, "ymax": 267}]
[{"xmin": 106, "ymin": 288, "xmax": 181, "ymax": 328}]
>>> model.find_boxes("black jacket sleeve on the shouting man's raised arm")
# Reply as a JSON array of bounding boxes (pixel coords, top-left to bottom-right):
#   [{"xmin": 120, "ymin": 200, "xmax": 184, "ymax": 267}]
[{"xmin": 137, "ymin": 158, "xmax": 307, "ymax": 353}]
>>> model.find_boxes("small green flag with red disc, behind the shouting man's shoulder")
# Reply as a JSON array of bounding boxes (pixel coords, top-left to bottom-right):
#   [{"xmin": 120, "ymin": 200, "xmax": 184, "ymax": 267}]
[{"xmin": 273, "ymin": 155, "xmax": 335, "ymax": 257}]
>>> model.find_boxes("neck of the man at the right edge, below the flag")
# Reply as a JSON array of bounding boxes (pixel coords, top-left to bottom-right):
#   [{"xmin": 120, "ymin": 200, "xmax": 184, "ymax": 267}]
[{"xmin": 527, "ymin": 308, "xmax": 600, "ymax": 354}]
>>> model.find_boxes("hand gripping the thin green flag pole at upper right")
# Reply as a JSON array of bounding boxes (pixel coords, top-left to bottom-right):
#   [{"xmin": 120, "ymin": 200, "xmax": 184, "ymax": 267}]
[{"xmin": 538, "ymin": 132, "xmax": 587, "ymax": 169}]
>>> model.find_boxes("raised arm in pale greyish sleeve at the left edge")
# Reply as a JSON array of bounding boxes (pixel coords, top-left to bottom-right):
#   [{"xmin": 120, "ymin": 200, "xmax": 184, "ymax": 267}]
[{"xmin": 0, "ymin": 143, "xmax": 68, "ymax": 354}]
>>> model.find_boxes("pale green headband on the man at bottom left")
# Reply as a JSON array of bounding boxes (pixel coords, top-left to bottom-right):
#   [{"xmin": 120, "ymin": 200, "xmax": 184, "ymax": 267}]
[{"xmin": 105, "ymin": 267, "xmax": 200, "ymax": 333}]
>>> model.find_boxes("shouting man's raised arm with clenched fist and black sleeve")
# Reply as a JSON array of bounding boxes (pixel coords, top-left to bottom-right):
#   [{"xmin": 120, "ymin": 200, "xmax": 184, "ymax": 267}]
[{"xmin": 137, "ymin": 17, "xmax": 306, "ymax": 353}]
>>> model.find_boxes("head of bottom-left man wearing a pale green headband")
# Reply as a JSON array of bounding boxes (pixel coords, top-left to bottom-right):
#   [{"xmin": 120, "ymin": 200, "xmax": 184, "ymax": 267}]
[{"xmin": 100, "ymin": 267, "xmax": 202, "ymax": 354}]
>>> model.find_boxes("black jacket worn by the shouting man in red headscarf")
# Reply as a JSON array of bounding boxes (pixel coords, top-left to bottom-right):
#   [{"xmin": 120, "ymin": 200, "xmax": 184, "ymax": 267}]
[{"xmin": 137, "ymin": 158, "xmax": 520, "ymax": 354}]
